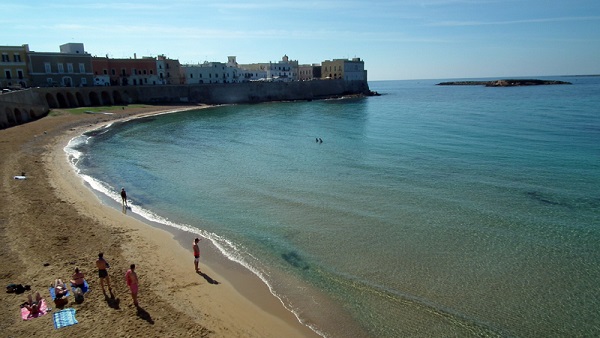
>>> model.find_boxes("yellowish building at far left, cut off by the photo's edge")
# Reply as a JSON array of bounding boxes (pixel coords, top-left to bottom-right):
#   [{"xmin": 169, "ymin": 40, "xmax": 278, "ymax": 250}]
[{"xmin": 0, "ymin": 45, "xmax": 30, "ymax": 88}]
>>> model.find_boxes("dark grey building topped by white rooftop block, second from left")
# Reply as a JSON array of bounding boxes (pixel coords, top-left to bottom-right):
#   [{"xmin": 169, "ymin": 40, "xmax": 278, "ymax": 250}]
[{"xmin": 27, "ymin": 43, "xmax": 93, "ymax": 87}]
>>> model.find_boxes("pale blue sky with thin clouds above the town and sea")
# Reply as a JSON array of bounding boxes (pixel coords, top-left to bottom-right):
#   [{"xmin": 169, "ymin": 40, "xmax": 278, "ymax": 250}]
[{"xmin": 0, "ymin": 0, "xmax": 600, "ymax": 80}]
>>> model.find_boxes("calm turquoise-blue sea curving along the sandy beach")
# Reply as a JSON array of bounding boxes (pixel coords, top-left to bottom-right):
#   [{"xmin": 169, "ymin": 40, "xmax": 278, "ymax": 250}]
[{"xmin": 68, "ymin": 77, "xmax": 600, "ymax": 337}]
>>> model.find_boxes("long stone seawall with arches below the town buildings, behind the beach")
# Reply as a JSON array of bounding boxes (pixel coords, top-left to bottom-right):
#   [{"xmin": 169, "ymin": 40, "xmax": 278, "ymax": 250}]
[{"xmin": 0, "ymin": 80, "xmax": 370, "ymax": 129}]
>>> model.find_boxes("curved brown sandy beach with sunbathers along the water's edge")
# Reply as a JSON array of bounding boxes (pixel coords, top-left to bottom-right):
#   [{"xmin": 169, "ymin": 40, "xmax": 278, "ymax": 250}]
[{"xmin": 0, "ymin": 106, "xmax": 318, "ymax": 337}]
